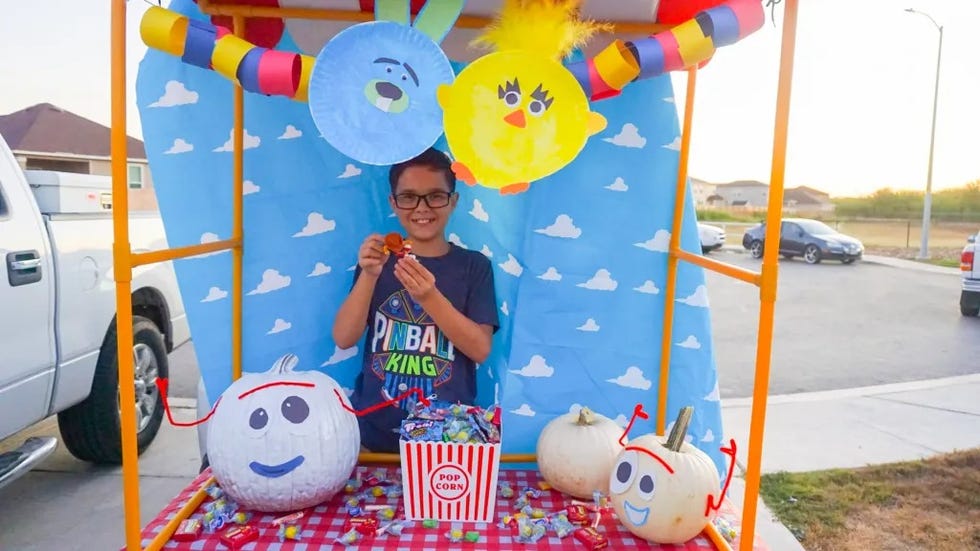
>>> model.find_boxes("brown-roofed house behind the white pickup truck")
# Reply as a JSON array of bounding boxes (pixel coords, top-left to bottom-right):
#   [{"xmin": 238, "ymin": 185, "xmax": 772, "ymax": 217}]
[{"xmin": 0, "ymin": 103, "xmax": 157, "ymax": 211}]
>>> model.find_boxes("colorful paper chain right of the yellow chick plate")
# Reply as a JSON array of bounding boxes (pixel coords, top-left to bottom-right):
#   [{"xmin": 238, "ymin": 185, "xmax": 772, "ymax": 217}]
[{"xmin": 568, "ymin": 0, "xmax": 765, "ymax": 101}]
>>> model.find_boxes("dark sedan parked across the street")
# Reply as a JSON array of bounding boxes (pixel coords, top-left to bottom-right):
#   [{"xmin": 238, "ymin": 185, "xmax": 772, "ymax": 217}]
[{"xmin": 742, "ymin": 218, "xmax": 864, "ymax": 264}]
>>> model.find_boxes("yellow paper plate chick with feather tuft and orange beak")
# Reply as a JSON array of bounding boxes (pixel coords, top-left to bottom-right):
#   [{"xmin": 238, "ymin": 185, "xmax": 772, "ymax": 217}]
[{"xmin": 439, "ymin": 0, "xmax": 606, "ymax": 194}]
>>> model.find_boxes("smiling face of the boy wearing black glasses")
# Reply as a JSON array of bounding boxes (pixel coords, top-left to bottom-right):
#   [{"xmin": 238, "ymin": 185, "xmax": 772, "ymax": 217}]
[{"xmin": 388, "ymin": 166, "xmax": 458, "ymax": 242}]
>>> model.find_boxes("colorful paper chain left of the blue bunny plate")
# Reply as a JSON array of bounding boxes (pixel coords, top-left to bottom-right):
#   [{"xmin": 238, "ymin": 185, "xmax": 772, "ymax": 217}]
[{"xmin": 140, "ymin": 6, "xmax": 315, "ymax": 101}]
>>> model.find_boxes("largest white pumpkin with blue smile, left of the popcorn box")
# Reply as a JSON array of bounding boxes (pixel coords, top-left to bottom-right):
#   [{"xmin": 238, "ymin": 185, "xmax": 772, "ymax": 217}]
[{"xmin": 208, "ymin": 354, "xmax": 361, "ymax": 512}]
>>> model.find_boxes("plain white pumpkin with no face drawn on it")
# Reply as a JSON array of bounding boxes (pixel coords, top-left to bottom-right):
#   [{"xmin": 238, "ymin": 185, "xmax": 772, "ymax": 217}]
[{"xmin": 537, "ymin": 407, "xmax": 623, "ymax": 500}]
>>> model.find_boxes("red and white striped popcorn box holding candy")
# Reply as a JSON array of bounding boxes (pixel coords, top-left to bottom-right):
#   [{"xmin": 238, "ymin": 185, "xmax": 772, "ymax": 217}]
[{"xmin": 400, "ymin": 440, "xmax": 500, "ymax": 522}]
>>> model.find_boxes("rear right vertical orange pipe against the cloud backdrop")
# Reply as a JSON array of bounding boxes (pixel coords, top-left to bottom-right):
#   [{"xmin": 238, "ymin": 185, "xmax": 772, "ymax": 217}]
[{"xmin": 657, "ymin": 65, "xmax": 698, "ymax": 434}]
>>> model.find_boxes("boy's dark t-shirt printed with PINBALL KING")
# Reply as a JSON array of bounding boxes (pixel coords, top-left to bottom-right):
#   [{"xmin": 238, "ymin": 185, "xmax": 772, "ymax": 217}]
[{"xmin": 351, "ymin": 244, "xmax": 499, "ymax": 452}]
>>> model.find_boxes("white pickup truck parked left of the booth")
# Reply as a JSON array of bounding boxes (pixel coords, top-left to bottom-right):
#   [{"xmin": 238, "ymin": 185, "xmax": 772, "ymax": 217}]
[{"xmin": 0, "ymin": 138, "xmax": 190, "ymax": 487}]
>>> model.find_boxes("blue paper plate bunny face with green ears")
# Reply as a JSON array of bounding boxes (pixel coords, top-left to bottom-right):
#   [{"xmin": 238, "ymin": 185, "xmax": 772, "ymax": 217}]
[{"xmin": 309, "ymin": 0, "xmax": 462, "ymax": 165}]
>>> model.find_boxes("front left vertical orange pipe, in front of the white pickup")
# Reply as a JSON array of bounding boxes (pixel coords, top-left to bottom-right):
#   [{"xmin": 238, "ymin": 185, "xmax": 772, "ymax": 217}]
[{"xmin": 110, "ymin": 0, "xmax": 140, "ymax": 551}]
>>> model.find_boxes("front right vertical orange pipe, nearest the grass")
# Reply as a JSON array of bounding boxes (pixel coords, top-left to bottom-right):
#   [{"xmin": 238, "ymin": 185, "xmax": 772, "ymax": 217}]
[{"xmin": 739, "ymin": 0, "xmax": 797, "ymax": 551}]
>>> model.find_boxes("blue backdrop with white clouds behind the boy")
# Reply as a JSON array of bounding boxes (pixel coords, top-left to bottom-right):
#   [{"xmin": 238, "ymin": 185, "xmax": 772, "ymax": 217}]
[{"xmin": 137, "ymin": 0, "xmax": 727, "ymax": 476}]
